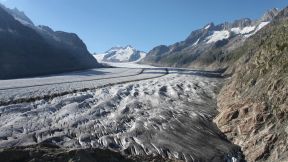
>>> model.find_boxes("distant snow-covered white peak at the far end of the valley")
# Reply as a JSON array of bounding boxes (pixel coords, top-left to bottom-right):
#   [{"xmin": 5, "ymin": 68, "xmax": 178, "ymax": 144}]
[{"xmin": 94, "ymin": 45, "xmax": 146, "ymax": 62}]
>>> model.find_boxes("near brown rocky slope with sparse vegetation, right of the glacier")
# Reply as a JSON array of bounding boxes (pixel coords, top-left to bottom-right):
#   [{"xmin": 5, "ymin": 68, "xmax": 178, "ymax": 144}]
[{"xmin": 215, "ymin": 8, "xmax": 288, "ymax": 161}]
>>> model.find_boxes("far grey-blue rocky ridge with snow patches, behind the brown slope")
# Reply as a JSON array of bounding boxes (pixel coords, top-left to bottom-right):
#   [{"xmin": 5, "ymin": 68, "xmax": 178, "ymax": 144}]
[{"xmin": 141, "ymin": 9, "xmax": 279, "ymax": 69}]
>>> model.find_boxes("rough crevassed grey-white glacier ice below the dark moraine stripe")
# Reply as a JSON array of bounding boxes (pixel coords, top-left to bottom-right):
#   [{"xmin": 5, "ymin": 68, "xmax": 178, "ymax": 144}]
[{"xmin": 0, "ymin": 68, "xmax": 239, "ymax": 161}]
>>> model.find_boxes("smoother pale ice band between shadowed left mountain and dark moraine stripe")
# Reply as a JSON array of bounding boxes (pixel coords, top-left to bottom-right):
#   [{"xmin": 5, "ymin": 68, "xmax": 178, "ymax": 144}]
[{"xmin": 0, "ymin": 68, "xmax": 166, "ymax": 105}]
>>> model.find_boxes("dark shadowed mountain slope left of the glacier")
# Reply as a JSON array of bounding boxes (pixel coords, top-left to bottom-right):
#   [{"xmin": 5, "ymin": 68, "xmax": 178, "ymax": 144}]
[{"xmin": 0, "ymin": 5, "xmax": 101, "ymax": 79}]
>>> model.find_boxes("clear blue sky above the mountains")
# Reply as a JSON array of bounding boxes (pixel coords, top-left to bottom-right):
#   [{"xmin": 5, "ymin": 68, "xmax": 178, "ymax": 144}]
[{"xmin": 0, "ymin": 0, "xmax": 288, "ymax": 53}]
